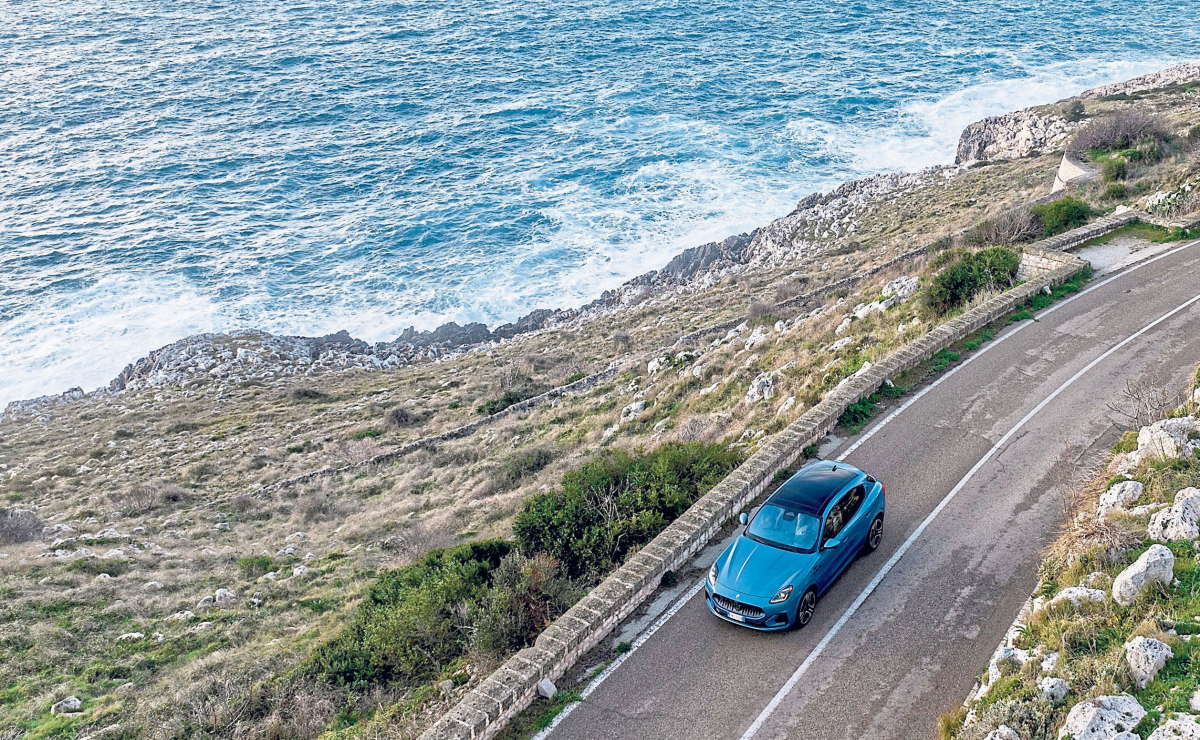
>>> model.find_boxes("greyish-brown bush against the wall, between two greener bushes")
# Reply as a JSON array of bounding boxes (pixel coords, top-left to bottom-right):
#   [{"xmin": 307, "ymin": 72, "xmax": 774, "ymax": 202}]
[{"xmin": 472, "ymin": 551, "xmax": 582, "ymax": 656}]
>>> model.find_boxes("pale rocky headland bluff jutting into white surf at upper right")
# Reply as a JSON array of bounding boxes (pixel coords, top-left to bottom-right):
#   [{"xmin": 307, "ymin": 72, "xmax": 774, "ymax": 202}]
[{"xmin": 954, "ymin": 109, "xmax": 1078, "ymax": 164}]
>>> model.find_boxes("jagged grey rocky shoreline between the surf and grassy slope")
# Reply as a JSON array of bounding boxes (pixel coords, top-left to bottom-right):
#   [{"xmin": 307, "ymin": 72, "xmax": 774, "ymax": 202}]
[{"xmin": 4, "ymin": 64, "xmax": 1200, "ymax": 415}]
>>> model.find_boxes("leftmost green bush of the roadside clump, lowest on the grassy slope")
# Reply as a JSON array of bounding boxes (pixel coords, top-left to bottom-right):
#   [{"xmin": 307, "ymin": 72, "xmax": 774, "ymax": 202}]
[{"xmin": 301, "ymin": 540, "xmax": 511, "ymax": 686}]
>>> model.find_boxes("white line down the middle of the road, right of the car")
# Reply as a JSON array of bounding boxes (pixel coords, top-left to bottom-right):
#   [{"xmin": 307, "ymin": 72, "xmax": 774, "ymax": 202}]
[{"xmin": 742, "ymin": 289, "xmax": 1200, "ymax": 740}]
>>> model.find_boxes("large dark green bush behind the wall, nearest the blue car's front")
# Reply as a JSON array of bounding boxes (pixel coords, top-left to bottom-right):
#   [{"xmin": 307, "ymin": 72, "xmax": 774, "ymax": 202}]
[{"xmin": 512, "ymin": 443, "xmax": 742, "ymax": 578}]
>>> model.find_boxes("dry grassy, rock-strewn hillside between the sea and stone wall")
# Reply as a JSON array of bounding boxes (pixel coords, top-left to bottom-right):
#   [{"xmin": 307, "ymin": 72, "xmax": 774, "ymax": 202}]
[{"xmin": 0, "ymin": 63, "xmax": 1200, "ymax": 738}]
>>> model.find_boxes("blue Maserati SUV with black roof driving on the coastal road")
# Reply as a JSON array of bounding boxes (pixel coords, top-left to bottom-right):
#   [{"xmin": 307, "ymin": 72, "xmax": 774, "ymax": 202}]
[{"xmin": 704, "ymin": 461, "xmax": 887, "ymax": 631}]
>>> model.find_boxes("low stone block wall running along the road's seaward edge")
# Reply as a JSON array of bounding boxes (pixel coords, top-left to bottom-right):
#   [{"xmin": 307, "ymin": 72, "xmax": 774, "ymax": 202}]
[{"xmin": 420, "ymin": 243, "xmax": 1112, "ymax": 740}]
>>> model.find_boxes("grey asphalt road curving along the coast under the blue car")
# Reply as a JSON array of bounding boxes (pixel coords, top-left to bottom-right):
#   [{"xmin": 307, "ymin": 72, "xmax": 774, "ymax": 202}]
[{"xmin": 550, "ymin": 242, "xmax": 1200, "ymax": 740}]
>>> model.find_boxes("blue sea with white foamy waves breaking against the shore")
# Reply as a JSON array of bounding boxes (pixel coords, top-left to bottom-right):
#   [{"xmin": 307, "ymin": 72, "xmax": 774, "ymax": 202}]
[{"xmin": 0, "ymin": 0, "xmax": 1200, "ymax": 404}]
